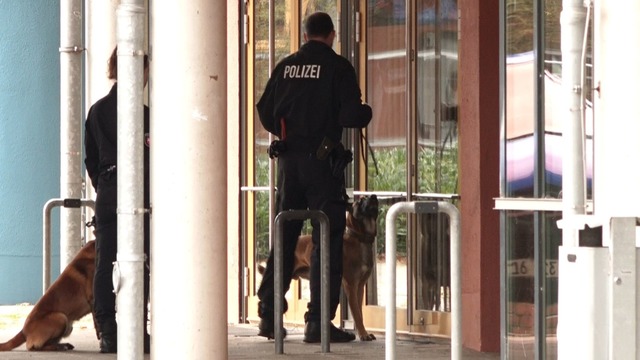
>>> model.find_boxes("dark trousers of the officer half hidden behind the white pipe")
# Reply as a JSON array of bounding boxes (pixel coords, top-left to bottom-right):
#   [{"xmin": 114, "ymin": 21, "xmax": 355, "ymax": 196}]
[{"xmin": 93, "ymin": 176, "xmax": 149, "ymax": 329}]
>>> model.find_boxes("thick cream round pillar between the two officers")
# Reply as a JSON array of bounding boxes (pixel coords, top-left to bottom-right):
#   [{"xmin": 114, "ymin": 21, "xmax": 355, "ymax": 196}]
[{"xmin": 149, "ymin": 0, "xmax": 228, "ymax": 360}]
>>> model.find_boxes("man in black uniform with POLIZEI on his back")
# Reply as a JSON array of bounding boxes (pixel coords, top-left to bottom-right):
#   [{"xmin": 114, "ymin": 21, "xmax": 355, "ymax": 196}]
[{"xmin": 257, "ymin": 12, "xmax": 371, "ymax": 343}]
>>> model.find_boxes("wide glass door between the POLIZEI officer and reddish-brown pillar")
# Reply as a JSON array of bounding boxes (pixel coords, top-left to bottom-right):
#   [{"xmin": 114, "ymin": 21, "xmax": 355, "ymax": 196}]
[{"xmin": 366, "ymin": 0, "xmax": 458, "ymax": 335}]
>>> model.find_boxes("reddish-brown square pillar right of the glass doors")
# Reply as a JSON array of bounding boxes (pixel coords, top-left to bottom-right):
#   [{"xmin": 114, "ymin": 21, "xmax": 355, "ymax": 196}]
[{"xmin": 458, "ymin": 0, "xmax": 500, "ymax": 351}]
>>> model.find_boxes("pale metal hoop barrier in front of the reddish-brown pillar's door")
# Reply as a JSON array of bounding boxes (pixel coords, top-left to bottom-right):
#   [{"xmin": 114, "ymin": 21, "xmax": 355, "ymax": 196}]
[{"xmin": 385, "ymin": 201, "xmax": 462, "ymax": 360}]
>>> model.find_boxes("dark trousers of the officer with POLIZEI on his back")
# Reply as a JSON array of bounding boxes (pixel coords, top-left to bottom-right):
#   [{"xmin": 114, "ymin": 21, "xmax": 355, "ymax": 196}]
[{"xmin": 258, "ymin": 152, "xmax": 346, "ymax": 322}]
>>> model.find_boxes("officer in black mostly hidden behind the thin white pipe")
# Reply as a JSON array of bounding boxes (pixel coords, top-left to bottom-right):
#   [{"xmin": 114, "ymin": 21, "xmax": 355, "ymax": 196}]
[{"xmin": 85, "ymin": 48, "xmax": 150, "ymax": 353}]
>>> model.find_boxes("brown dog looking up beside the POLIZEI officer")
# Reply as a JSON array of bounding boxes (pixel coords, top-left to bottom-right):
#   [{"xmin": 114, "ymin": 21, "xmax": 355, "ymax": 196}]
[{"xmin": 293, "ymin": 195, "xmax": 378, "ymax": 341}]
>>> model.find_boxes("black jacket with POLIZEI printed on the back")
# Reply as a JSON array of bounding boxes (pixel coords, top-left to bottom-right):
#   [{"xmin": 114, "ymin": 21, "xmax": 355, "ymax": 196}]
[{"xmin": 257, "ymin": 40, "xmax": 371, "ymax": 151}]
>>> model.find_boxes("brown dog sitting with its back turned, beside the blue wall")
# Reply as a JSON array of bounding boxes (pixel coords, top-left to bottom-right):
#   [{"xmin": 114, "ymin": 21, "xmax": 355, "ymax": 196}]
[{"xmin": 0, "ymin": 241, "xmax": 96, "ymax": 351}]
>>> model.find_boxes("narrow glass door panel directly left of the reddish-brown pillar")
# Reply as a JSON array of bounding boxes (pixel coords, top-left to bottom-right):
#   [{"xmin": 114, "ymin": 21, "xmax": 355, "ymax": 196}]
[{"xmin": 415, "ymin": 0, "xmax": 458, "ymax": 311}]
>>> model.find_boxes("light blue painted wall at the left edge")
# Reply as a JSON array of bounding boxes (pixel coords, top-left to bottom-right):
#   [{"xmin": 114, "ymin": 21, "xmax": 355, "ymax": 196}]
[{"xmin": 0, "ymin": 0, "xmax": 60, "ymax": 304}]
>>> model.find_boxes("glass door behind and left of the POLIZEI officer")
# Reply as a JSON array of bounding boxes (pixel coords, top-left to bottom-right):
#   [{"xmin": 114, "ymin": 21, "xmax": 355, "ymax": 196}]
[{"xmin": 241, "ymin": 0, "xmax": 340, "ymax": 323}]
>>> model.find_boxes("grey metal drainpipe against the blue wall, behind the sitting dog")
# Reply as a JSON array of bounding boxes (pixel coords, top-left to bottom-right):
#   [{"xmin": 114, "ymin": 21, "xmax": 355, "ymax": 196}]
[{"xmin": 60, "ymin": 0, "xmax": 84, "ymax": 272}]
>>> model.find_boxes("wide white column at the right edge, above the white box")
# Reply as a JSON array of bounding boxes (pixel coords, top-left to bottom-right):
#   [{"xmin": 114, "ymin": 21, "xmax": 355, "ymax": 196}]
[{"xmin": 594, "ymin": 0, "xmax": 640, "ymax": 217}]
